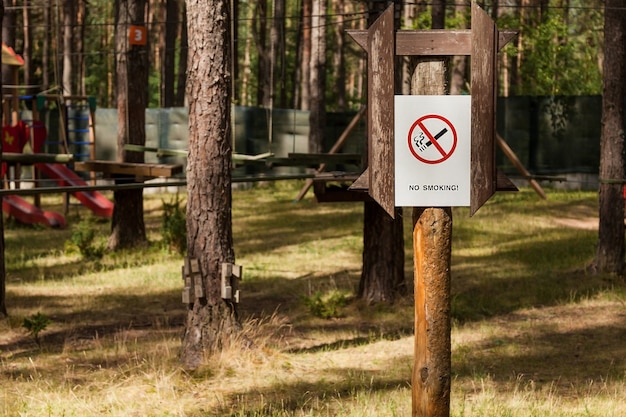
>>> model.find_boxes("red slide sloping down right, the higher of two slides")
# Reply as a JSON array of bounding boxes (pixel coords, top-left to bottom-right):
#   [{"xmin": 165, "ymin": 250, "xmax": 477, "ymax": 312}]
[{"xmin": 35, "ymin": 163, "xmax": 113, "ymax": 217}]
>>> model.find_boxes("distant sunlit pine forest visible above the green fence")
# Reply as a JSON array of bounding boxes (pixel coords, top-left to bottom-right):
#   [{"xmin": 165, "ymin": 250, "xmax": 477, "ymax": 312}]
[{"xmin": 2, "ymin": 0, "xmax": 604, "ymax": 111}]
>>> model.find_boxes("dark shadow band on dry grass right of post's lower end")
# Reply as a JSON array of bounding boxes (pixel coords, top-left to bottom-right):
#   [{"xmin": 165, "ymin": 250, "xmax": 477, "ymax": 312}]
[{"xmin": 452, "ymin": 314, "xmax": 626, "ymax": 386}]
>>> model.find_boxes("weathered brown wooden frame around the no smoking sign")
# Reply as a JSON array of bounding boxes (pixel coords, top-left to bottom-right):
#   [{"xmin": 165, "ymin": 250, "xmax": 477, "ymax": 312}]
[{"xmin": 347, "ymin": 3, "xmax": 517, "ymax": 217}]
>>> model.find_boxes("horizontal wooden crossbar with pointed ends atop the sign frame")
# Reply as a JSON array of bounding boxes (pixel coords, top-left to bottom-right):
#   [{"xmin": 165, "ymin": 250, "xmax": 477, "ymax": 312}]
[{"xmin": 346, "ymin": 29, "xmax": 518, "ymax": 56}]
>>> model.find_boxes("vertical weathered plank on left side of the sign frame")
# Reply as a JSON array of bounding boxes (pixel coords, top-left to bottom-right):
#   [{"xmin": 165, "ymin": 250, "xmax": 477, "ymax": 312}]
[{"xmin": 367, "ymin": 4, "xmax": 395, "ymax": 218}]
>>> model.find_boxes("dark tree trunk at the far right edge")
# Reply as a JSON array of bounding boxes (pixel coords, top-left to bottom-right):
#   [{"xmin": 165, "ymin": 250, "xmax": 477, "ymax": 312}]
[{"xmin": 595, "ymin": 0, "xmax": 626, "ymax": 275}]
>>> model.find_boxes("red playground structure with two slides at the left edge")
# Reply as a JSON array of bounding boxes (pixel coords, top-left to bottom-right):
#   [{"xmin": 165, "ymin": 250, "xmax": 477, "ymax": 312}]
[{"xmin": 0, "ymin": 45, "xmax": 113, "ymax": 227}]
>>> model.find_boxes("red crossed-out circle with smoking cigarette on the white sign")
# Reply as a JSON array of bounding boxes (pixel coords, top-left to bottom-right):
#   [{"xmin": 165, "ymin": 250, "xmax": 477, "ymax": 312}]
[{"xmin": 408, "ymin": 114, "xmax": 457, "ymax": 164}]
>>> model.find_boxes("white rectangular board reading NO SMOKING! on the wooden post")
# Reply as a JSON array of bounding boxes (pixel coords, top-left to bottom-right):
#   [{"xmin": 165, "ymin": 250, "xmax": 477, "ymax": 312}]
[{"xmin": 394, "ymin": 95, "xmax": 471, "ymax": 207}]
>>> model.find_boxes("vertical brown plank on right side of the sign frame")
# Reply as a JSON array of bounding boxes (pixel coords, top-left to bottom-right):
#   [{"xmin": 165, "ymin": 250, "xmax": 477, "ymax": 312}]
[{"xmin": 470, "ymin": 3, "xmax": 498, "ymax": 216}]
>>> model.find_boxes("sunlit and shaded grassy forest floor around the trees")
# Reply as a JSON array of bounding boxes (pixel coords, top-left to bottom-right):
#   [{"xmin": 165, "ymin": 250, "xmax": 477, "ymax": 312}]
[{"xmin": 0, "ymin": 182, "xmax": 626, "ymax": 417}]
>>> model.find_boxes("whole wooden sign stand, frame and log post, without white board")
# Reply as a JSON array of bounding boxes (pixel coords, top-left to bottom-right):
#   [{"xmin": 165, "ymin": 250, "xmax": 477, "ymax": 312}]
[{"xmin": 349, "ymin": 2, "xmax": 516, "ymax": 417}]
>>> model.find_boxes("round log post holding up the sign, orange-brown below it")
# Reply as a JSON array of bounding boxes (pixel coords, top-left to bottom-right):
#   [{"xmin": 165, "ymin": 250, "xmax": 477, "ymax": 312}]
[{"xmin": 411, "ymin": 59, "xmax": 452, "ymax": 417}]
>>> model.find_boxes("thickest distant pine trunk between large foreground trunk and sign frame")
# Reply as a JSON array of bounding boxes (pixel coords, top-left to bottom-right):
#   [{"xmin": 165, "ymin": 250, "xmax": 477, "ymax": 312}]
[{"xmin": 309, "ymin": 0, "xmax": 326, "ymax": 153}]
